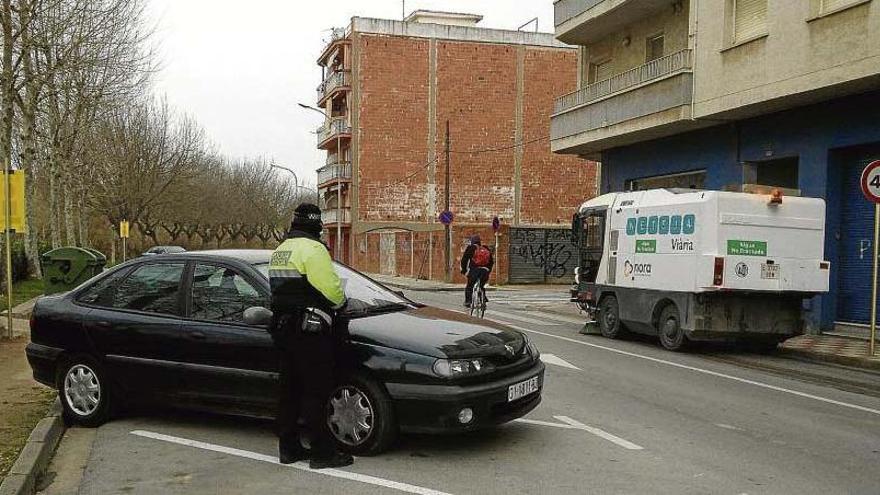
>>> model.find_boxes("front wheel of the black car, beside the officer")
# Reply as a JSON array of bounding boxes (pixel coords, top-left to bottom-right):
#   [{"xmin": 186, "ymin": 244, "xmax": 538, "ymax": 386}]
[{"xmin": 327, "ymin": 374, "xmax": 398, "ymax": 456}]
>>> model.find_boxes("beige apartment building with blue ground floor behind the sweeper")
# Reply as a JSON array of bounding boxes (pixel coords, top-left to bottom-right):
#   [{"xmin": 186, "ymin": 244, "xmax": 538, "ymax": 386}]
[{"xmin": 551, "ymin": 0, "xmax": 880, "ymax": 331}]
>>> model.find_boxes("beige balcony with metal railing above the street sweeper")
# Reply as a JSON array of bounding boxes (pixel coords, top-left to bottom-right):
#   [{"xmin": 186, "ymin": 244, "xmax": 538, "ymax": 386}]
[{"xmin": 550, "ymin": 49, "xmax": 701, "ymax": 156}]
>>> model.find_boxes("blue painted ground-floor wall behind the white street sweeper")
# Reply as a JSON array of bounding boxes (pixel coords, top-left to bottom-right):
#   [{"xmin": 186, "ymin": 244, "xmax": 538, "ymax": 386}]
[{"xmin": 602, "ymin": 91, "xmax": 880, "ymax": 329}]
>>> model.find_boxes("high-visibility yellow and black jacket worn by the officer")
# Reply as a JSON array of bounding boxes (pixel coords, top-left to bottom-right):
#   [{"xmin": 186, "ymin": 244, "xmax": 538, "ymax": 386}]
[{"xmin": 269, "ymin": 237, "xmax": 345, "ymax": 312}]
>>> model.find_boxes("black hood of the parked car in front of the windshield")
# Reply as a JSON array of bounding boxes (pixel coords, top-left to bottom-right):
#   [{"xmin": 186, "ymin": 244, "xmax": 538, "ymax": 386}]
[{"xmin": 348, "ymin": 306, "xmax": 525, "ymax": 359}]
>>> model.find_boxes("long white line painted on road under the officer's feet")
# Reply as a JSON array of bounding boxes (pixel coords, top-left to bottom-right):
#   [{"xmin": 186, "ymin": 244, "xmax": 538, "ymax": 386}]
[{"xmin": 131, "ymin": 430, "xmax": 451, "ymax": 495}]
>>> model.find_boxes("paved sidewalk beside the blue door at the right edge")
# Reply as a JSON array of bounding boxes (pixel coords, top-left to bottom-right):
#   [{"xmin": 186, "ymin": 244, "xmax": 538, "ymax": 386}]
[{"xmin": 780, "ymin": 334, "xmax": 880, "ymax": 371}]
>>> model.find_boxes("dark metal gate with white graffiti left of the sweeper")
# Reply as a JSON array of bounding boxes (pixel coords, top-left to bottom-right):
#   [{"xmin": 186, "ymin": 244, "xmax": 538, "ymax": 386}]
[{"xmin": 508, "ymin": 228, "xmax": 577, "ymax": 284}]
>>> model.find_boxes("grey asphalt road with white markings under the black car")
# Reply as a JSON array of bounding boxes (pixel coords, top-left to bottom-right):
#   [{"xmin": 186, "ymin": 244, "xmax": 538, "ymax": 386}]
[{"xmin": 37, "ymin": 291, "xmax": 880, "ymax": 495}]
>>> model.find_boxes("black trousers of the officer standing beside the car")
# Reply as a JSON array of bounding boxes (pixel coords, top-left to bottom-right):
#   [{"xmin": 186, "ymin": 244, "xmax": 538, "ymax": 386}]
[{"xmin": 277, "ymin": 331, "xmax": 336, "ymax": 459}]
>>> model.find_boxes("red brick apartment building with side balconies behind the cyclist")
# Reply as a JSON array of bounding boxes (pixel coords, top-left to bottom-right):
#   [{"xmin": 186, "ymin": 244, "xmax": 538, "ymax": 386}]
[{"xmin": 318, "ymin": 11, "xmax": 597, "ymax": 282}]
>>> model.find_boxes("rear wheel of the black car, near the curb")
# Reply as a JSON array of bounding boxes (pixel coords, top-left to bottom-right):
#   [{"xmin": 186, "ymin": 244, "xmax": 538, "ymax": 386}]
[{"xmin": 57, "ymin": 355, "xmax": 111, "ymax": 428}]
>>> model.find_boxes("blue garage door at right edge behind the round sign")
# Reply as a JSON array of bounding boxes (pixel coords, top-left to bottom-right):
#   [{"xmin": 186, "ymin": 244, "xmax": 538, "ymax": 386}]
[{"xmin": 837, "ymin": 150, "xmax": 880, "ymax": 324}]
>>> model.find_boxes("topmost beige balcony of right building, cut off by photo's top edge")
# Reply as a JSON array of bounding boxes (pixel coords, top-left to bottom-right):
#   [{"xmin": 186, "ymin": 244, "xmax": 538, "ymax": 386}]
[{"xmin": 553, "ymin": 0, "xmax": 672, "ymax": 45}]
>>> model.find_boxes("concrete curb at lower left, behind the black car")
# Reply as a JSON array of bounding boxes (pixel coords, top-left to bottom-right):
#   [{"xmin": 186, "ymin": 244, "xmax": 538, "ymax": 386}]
[{"xmin": 0, "ymin": 398, "xmax": 65, "ymax": 495}]
